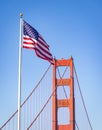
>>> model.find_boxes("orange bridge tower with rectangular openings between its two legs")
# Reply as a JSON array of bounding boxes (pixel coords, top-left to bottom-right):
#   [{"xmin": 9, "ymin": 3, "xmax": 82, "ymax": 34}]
[{"xmin": 52, "ymin": 57, "xmax": 75, "ymax": 130}]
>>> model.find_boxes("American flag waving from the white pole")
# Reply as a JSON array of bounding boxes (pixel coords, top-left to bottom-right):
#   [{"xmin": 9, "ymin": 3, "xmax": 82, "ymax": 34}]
[{"xmin": 23, "ymin": 20, "xmax": 53, "ymax": 64}]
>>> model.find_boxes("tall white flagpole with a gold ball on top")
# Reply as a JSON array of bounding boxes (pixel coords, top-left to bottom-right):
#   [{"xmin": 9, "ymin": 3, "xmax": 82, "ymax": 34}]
[{"xmin": 18, "ymin": 13, "xmax": 23, "ymax": 130}]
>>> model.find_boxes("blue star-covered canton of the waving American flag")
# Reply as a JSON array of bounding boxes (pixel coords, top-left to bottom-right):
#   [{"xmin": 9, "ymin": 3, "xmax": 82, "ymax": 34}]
[{"xmin": 23, "ymin": 21, "xmax": 39, "ymax": 40}]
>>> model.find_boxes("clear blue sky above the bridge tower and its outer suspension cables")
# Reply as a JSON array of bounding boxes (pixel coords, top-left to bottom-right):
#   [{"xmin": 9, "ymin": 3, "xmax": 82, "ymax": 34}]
[{"xmin": 0, "ymin": 0, "xmax": 102, "ymax": 130}]
